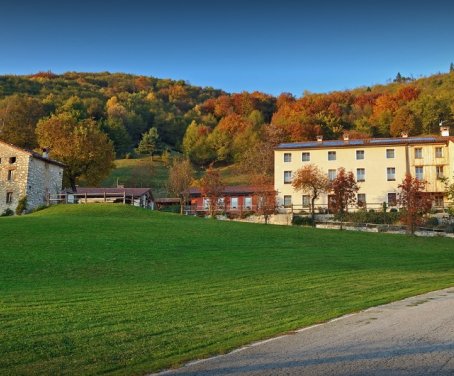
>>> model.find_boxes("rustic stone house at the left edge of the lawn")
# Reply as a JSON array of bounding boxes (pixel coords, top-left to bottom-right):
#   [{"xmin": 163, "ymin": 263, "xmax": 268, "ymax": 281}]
[{"xmin": 0, "ymin": 141, "xmax": 65, "ymax": 214}]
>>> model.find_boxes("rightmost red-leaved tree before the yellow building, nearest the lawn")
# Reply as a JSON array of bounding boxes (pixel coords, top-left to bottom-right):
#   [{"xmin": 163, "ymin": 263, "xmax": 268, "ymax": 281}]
[{"xmin": 398, "ymin": 174, "xmax": 432, "ymax": 235}]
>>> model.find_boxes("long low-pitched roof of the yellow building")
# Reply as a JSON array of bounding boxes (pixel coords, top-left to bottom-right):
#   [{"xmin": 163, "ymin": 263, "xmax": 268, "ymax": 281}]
[{"xmin": 276, "ymin": 136, "xmax": 453, "ymax": 150}]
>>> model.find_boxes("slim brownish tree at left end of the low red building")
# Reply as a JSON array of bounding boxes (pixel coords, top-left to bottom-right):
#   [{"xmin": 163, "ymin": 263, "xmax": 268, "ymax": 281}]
[{"xmin": 167, "ymin": 158, "xmax": 194, "ymax": 214}]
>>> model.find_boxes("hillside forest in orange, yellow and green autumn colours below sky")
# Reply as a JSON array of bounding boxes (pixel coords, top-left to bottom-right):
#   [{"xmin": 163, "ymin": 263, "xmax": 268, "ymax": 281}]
[{"xmin": 0, "ymin": 67, "xmax": 454, "ymax": 172}]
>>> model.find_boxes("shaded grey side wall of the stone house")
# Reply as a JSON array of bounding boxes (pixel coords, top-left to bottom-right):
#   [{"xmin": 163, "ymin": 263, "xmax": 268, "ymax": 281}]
[{"xmin": 27, "ymin": 156, "xmax": 63, "ymax": 210}]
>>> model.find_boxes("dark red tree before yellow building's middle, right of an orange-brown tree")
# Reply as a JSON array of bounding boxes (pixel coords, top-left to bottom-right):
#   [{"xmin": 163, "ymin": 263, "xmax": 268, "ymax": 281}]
[{"xmin": 331, "ymin": 167, "xmax": 359, "ymax": 219}]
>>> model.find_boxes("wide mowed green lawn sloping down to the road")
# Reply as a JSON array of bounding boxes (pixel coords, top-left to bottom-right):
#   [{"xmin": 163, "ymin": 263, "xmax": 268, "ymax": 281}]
[{"xmin": 0, "ymin": 205, "xmax": 454, "ymax": 375}]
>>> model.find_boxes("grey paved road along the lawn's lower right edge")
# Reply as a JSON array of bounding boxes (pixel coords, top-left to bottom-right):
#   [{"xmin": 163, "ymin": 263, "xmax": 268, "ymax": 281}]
[{"xmin": 161, "ymin": 288, "xmax": 454, "ymax": 376}]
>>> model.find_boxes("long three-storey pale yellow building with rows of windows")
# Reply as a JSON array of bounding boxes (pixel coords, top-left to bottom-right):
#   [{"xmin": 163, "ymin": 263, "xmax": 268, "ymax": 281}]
[{"xmin": 274, "ymin": 127, "xmax": 454, "ymax": 209}]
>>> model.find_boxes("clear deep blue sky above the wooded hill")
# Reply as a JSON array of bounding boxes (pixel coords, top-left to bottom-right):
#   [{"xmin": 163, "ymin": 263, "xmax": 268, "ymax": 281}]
[{"xmin": 0, "ymin": 0, "xmax": 454, "ymax": 96}]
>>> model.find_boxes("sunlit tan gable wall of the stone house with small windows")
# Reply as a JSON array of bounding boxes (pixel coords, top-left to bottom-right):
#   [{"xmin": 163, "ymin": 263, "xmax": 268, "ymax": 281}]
[{"xmin": 0, "ymin": 143, "xmax": 30, "ymax": 214}]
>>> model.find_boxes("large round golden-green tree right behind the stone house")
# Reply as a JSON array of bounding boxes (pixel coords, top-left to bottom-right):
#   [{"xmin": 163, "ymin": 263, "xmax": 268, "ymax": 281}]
[{"xmin": 36, "ymin": 113, "xmax": 115, "ymax": 190}]
